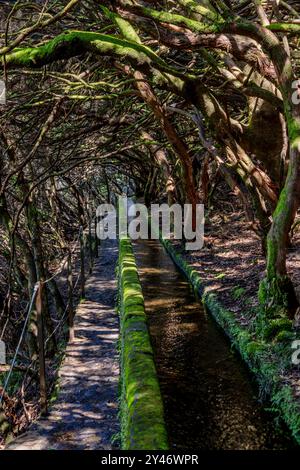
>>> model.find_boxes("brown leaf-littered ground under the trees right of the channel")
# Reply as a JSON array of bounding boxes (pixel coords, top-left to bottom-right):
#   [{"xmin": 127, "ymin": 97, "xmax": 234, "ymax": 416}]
[{"xmin": 176, "ymin": 204, "xmax": 300, "ymax": 326}]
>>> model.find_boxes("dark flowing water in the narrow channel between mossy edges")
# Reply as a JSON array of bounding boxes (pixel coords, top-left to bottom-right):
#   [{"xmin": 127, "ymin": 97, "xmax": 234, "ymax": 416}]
[{"xmin": 134, "ymin": 240, "xmax": 295, "ymax": 450}]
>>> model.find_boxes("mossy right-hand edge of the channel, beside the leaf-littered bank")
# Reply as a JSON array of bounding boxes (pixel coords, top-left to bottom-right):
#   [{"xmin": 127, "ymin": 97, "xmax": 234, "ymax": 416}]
[{"xmin": 160, "ymin": 236, "xmax": 300, "ymax": 445}]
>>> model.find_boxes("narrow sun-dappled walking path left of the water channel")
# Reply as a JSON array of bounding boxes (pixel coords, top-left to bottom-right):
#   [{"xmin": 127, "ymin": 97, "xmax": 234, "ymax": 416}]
[{"xmin": 7, "ymin": 240, "xmax": 119, "ymax": 450}]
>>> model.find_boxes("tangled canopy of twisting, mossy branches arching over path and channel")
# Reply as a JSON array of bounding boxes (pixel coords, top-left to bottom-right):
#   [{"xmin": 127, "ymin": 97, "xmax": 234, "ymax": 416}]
[{"xmin": 0, "ymin": 0, "xmax": 300, "ymax": 356}]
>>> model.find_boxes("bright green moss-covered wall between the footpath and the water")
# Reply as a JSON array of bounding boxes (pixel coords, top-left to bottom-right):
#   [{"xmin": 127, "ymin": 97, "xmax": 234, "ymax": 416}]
[{"xmin": 118, "ymin": 238, "xmax": 169, "ymax": 450}]
